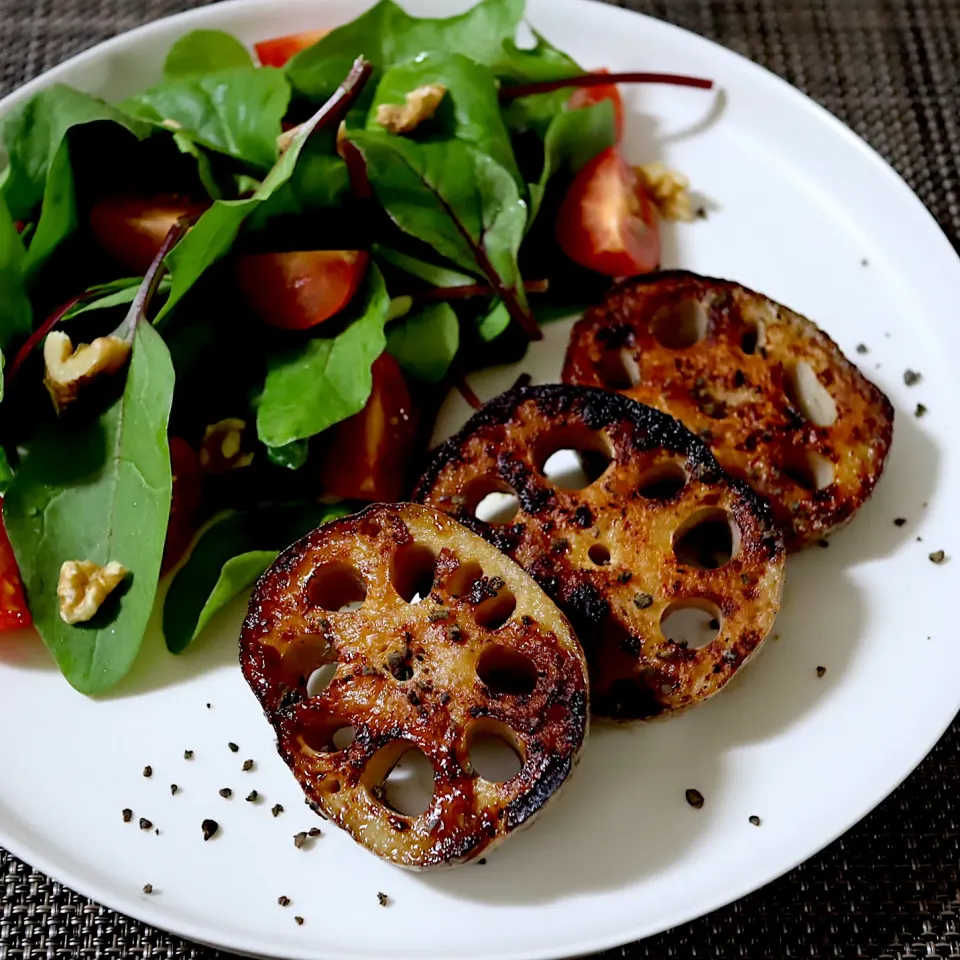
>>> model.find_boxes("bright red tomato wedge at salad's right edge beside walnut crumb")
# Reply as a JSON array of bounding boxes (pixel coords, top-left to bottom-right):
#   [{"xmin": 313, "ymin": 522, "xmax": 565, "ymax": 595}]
[{"xmin": 557, "ymin": 147, "xmax": 660, "ymax": 277}]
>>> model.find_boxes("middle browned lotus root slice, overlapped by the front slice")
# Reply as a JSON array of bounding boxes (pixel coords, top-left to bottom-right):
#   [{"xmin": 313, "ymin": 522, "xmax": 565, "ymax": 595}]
[{"xmin": 414, "ymin": 385, "xmax": 784, "ymax": 720}]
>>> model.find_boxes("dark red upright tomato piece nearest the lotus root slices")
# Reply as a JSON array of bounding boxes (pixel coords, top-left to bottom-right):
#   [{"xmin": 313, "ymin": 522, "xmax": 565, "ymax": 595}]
[{"xmin": 320, "ymin": 353, "xmax": 418, "ymax": 503}]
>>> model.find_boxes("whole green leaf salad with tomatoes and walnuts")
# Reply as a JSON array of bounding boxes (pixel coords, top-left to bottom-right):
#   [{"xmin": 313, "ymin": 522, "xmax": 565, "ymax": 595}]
[{"xmin": 0, "ymin": 0, "xmax": 709, "ymax": 694}]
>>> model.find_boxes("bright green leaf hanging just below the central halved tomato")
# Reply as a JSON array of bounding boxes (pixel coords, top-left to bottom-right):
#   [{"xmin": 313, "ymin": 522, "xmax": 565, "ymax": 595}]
[{"xmin": 257, "ymin": 266, "xmax": 390, "ymax": 447}]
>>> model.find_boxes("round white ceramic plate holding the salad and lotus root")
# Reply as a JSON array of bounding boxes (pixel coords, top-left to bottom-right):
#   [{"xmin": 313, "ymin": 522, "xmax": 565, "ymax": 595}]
[{"xmin": 0, "ymin": 0, "xmax": 960, "ymax": 960}]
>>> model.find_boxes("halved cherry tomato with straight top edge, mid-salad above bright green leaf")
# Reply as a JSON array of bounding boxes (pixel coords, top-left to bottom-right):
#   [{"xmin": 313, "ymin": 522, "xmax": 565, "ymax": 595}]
[{"xmin": 237, "ymin": 250, "xmax": 370, "ymax": 330}]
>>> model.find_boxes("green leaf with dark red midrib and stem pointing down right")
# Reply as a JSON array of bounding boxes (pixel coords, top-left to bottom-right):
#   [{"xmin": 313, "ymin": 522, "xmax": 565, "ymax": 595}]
[{"xmin": 350, "ymin": 130, "xmax": 539, "ymax": 337}]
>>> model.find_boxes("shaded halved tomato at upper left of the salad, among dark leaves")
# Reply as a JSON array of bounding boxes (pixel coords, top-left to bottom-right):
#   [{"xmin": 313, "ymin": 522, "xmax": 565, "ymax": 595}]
[{"xmin": 90, "ymin": 194, "xmax": 208, "ymax": 275}]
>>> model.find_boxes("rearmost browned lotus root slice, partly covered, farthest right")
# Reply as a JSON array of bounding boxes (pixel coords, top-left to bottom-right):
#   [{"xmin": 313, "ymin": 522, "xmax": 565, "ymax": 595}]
[{"xmin": 563, "ymin": 272, "xmax": 893, "ymax": 550}]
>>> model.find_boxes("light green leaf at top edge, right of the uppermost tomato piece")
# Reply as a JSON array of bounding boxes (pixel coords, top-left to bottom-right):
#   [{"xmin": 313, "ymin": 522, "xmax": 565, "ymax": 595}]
[{"xmin": 287, "ymin": 0, "xmax": 525, "ymax": 99}]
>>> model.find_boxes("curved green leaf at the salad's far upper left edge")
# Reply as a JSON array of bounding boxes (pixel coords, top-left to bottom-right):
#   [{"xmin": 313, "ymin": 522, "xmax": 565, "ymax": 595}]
[{"xmin": 0, "ymin": 83, "xmax": 152, "ymax": 220}]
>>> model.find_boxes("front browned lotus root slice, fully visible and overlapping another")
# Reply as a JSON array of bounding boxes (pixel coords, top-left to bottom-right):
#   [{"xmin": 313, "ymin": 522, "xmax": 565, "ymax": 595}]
[{"xmin": 240, "ymin": 504, "xmax": 589, "ymax": 868}]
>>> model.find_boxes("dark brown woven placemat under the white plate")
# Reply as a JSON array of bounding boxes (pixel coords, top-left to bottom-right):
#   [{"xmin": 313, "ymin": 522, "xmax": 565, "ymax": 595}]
[{"xmin": 0, "ymin": 0, "xmax": 960, "ymax": 960}]
